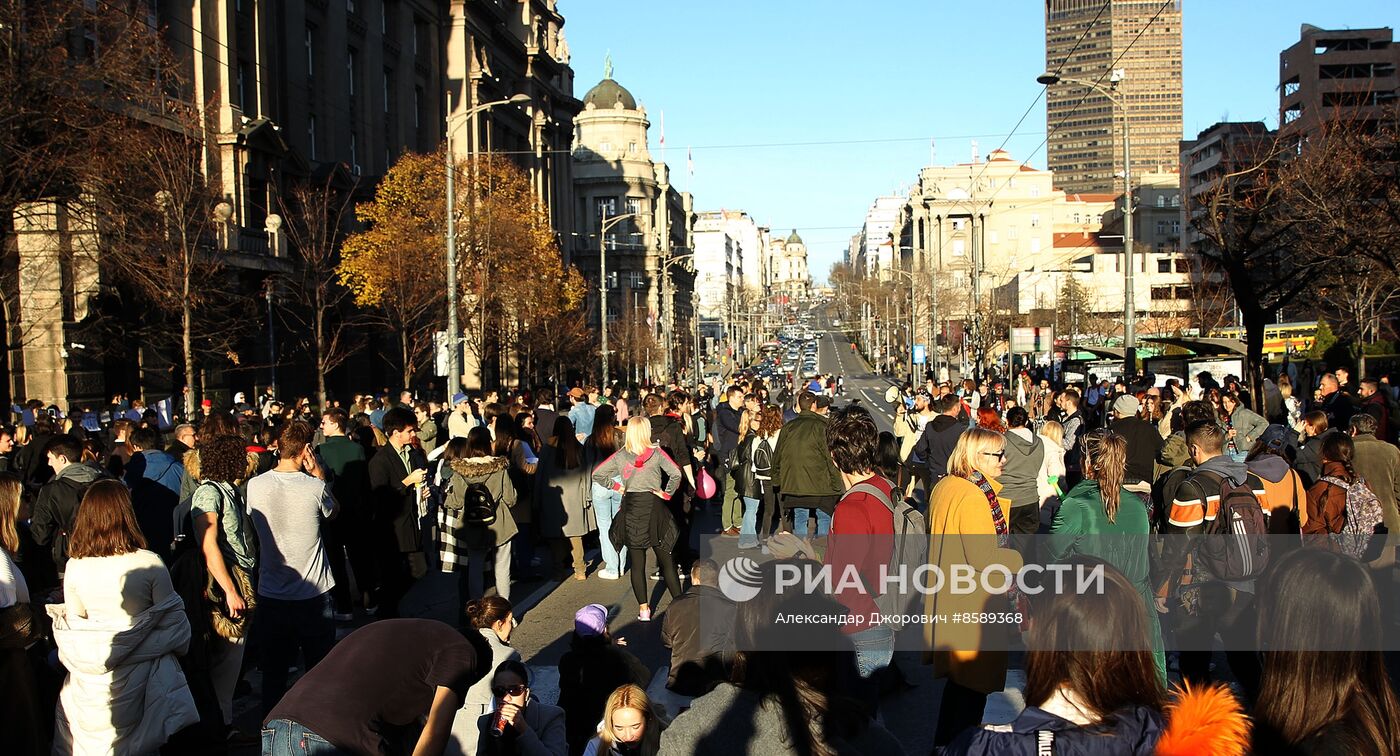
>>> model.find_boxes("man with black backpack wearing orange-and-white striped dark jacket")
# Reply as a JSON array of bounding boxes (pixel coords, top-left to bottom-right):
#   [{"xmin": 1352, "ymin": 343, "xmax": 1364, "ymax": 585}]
[{"xmin": 1156, "ymin": 421, "xmax": 1268, "ymax": 701}]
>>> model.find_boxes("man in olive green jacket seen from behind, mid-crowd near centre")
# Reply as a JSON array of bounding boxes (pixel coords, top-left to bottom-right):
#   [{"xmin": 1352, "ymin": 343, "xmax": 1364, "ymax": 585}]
[{"xmin": 773, "ymin": 391, "xmax": 846, "ymax": 535}]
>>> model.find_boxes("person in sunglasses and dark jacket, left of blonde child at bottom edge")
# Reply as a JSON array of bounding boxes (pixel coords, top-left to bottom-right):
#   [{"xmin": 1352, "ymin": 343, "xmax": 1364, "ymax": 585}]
[{"xmin": 476, "ymin": 659, "xmax": 568, "ymax": 756}]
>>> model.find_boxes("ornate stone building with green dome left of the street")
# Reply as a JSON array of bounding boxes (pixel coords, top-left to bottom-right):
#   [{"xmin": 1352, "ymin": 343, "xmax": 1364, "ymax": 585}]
[{"xmin": 570, "ymin": 60, "xmax": 694, "ymax": 379}]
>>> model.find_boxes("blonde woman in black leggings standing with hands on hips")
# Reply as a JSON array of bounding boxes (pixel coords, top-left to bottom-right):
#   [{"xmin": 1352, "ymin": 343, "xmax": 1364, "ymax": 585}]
[{"xmin": 594, "ymin": 417, "xmax": 680, "ymax": 622}]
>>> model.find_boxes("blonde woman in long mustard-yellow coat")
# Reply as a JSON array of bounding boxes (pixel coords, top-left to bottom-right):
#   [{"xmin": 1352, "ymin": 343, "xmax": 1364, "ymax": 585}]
[{"xmin": 924, "ymin": 428, "xmax": 1022, "ymax": 746}]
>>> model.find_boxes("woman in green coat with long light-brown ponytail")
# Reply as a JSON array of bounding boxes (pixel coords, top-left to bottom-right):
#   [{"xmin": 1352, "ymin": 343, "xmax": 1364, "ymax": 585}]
[{"xmin": 1047, "ymin": 430, "xmax": 1166, "ymax": 680}]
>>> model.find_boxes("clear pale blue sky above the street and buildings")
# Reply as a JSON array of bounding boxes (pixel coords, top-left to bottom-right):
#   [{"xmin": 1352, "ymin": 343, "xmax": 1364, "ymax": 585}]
[{"xmin": 559, "ymin": 0, "xmax": 1400, "ymax": 280}]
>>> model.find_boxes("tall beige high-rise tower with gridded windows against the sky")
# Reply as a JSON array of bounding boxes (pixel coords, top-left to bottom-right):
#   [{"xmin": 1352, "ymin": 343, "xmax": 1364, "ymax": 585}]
[{"xmin": 1046, "ymin": 0, "xmax": 1182, "ymax": 193}]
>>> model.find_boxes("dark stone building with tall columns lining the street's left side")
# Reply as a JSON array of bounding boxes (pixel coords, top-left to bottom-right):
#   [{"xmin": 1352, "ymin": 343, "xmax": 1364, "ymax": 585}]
[{"xmin": 7, "ymin": 0, "xmax": 582, "ymax": 403}]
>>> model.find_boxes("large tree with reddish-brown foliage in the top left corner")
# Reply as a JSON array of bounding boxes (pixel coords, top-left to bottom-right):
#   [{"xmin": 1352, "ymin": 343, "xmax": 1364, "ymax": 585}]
[{"xmin": 0, "ymin": 0, "xmax": 175, "ymax": 394}]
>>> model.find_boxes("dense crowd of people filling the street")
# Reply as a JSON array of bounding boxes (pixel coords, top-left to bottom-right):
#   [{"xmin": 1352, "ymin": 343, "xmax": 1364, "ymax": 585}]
[{"xmin": 0, "ymin": 355, "xmax": 1400, "ymax": 756}]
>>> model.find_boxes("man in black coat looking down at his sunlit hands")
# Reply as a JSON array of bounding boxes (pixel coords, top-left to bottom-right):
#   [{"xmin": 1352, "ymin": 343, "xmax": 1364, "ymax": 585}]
[{"xmin": 370, "ymin": 407, "xmax": 428, "ymax": 616}]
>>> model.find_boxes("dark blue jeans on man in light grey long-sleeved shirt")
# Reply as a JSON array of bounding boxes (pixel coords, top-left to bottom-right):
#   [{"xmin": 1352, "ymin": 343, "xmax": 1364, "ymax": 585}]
[{"xmin": 253, "ymin": 591, "xmax": 336, "ymax": 717}]
